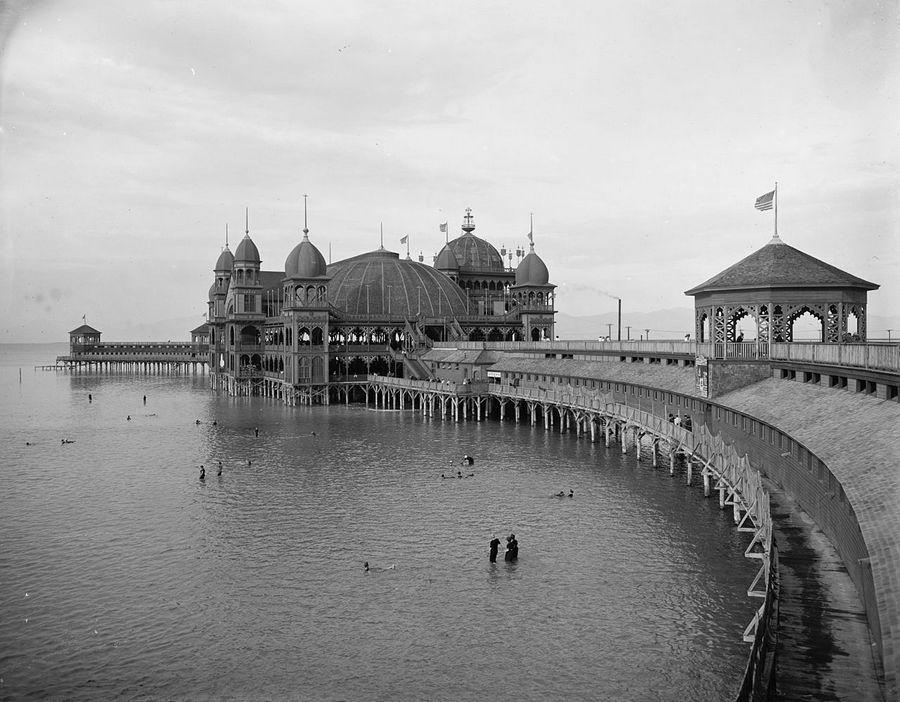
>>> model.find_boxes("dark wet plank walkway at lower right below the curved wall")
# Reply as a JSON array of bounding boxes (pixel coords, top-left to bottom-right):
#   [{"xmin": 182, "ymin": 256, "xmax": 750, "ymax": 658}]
[{"xmin": 766, "ymin": 484, "xmax": 885, "ymax": 702}]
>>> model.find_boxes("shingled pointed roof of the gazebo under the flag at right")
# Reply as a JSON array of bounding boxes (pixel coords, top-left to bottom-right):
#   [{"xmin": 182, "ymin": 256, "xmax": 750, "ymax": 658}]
[{"xmin": 684, "ymin": 235, "xmax": 879, "ymax": 295}]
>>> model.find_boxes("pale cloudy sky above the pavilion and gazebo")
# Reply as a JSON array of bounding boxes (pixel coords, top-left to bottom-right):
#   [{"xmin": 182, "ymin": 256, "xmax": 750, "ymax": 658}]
[{"xmin": 0, "ymin": 0, "xmax": 900, "ymax": 342}]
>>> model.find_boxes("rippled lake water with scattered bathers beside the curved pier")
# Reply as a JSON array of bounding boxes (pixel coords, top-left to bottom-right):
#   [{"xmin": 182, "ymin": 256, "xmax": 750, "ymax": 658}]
[{"xmin": 0, "ymin": 345, "xmax": 757, "ymax": 700}]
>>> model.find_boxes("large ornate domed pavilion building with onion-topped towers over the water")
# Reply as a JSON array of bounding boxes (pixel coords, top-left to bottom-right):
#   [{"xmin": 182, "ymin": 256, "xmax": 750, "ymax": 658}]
[{"xmin": 208, "ymin": 210, "xmax": 556, "ymax": 403}]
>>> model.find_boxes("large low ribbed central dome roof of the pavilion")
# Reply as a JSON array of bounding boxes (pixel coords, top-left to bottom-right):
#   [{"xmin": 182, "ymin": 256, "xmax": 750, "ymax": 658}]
[{"xmin": 328, "ymin": 249, "xmax": 467, "ymax": 319}]
